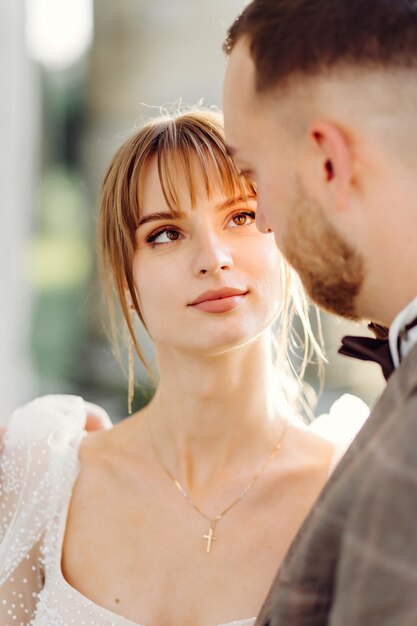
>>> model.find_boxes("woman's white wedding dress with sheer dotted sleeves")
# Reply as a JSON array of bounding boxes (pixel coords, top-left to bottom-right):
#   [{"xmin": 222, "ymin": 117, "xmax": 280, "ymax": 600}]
[{"xmin": 0, "ymin": 396, "xmax": 367, "ymax": 626}]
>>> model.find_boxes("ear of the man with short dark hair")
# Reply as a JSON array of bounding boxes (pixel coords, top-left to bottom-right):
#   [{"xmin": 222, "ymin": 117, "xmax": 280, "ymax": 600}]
[{"xmin": 308, "ymin": 120, "xmax": 352, "ymax": 211}]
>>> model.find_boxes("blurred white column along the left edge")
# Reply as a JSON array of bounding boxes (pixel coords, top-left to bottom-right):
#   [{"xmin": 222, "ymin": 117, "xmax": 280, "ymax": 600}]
[{"xmin": 0, "ymin": 0, "xmax": 38, "ymax": 423}]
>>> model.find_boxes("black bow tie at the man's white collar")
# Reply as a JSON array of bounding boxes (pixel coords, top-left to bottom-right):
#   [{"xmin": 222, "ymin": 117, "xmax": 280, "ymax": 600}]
[{"xmin": 338, "ymin": 318, "xmax": 417, "ymax": 380}]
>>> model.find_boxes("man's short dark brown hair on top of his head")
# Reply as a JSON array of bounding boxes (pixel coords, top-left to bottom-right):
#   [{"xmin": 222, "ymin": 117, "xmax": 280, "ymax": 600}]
[{"xmin": 224, "ymin": 0, "xmax": 417, "ymax": 92}]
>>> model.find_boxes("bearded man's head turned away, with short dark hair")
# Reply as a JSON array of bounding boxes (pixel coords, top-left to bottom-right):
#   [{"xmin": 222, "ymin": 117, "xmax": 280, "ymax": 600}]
[{"xmin": 224, "ymin": 0, "xmax": 417, "ymax": 324}]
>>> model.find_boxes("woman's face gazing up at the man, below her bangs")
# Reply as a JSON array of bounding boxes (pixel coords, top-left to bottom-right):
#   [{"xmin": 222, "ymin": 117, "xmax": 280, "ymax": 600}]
[{"xmin": 133, "ymin": 158, "xmax": 281, "ymax": 355}]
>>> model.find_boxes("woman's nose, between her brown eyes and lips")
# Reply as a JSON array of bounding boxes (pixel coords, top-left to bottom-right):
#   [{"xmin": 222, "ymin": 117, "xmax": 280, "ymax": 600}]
[{"xmin": 193, "ymin": 232, "xmax": 233, "ymax": 276}]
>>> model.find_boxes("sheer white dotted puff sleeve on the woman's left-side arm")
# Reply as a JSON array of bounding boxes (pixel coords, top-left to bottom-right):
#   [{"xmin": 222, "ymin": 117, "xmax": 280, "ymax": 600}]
[{"xmin": 0, "ymin": 396, "xmax": 85, "ymax": 626}]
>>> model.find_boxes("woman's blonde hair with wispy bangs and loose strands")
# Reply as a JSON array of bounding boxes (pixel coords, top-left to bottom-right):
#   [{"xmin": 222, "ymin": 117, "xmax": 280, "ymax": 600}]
[{"xmin": 98, "ymin": 108, "xmax": 322, "ymax": 414}]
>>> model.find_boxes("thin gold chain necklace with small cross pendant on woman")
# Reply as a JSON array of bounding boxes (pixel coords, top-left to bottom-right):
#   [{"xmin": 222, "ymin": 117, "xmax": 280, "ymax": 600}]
[{"xmin": 145, "ymin": 416, "xmax": 288, "ymax": 552}]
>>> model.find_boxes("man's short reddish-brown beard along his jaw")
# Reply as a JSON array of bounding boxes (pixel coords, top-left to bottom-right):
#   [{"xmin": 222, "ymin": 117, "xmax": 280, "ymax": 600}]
[{"xmin": 281, "ymin": 180, "xmax": 365, "ymax": 320}]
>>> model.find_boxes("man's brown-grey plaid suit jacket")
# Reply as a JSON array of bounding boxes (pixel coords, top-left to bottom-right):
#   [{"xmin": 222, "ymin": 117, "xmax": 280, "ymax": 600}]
[{"xmin": 256, "ymin": 346, "xmax": 417, "ymax": 626}]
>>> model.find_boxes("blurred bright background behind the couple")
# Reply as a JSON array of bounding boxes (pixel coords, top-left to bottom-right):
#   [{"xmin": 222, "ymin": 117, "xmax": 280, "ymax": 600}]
[{"xmin": 0, "ymin": 0, "xmax": 383, "ymax": 422}]
